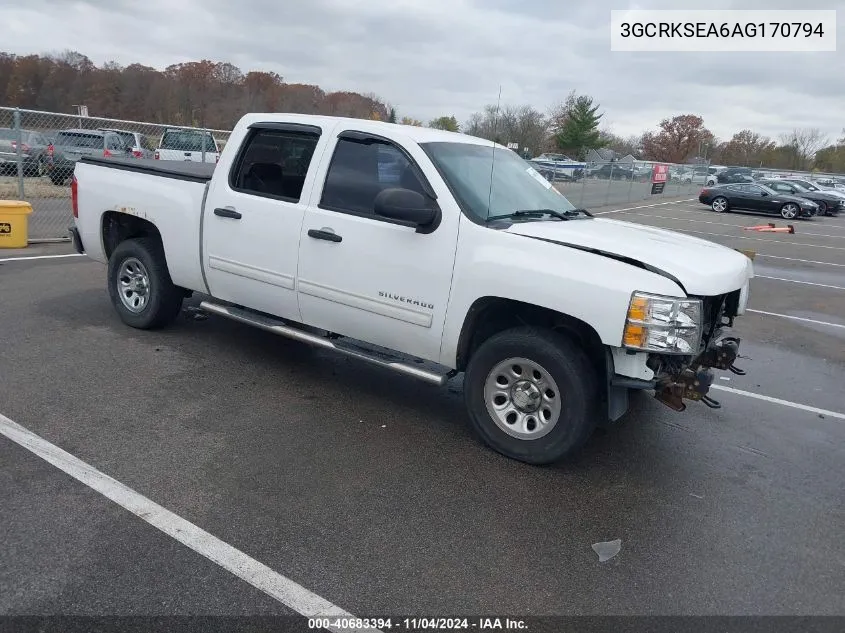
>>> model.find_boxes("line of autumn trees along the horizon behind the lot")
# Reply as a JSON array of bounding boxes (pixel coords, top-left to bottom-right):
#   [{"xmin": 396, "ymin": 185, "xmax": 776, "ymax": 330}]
[{"xmin": 0, "ymin": 51, "xmax": 845, "ymax": 172}]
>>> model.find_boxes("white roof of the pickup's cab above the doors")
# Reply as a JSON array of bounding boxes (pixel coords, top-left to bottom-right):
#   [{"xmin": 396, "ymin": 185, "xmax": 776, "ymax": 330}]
[{"xmin": 236, "ymin": 112, "xmax": 494, "ymax": 149}]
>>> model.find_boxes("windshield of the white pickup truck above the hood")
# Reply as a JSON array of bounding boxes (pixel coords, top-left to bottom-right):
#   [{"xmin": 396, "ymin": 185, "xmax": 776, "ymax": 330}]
[{"xmin": 421, "ymin": 143, "xmax": 575, "ymax": 222}]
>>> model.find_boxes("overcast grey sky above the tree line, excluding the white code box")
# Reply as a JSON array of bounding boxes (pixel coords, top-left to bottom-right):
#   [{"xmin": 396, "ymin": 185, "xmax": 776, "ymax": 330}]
[{"xmin": 0, "ymin": 0, "xmax": 845, "ymax": 139}]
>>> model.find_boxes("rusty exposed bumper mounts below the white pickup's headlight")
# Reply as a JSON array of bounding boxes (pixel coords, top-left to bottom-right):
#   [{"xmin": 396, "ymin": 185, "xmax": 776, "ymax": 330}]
[{"xmin": 654, "ymin": 336, "xmax": 745, "ymax": 411}]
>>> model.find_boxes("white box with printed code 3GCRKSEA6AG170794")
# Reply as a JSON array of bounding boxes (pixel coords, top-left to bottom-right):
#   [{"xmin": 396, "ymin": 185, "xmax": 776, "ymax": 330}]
[{"xmin": 610, "ymin": 10, "xmax": 836, "ymax": 52}]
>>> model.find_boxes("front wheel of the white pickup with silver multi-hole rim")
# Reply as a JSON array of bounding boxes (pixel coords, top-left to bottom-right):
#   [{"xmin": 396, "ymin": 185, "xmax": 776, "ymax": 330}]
[{"xmin": 464, "ymin": 327, "xmax": 599, "ymax": 464}]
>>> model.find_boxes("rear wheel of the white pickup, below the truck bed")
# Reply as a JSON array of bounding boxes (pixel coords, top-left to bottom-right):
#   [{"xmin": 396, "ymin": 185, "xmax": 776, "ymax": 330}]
[{"xmin": 108, "ymin": 237, "xmax": 184, "ymax": 330}]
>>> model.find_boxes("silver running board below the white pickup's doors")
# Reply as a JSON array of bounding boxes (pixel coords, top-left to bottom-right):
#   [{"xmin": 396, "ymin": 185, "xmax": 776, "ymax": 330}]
[{"xmin": 199, "ymin": 301, "xmax": 450, "ymax": 387}]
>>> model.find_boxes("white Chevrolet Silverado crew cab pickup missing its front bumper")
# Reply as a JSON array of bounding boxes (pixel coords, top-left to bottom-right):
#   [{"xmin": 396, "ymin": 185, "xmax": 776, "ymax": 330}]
[{"xmin": 70, "ymin": 114, "xmax": 753, "ymax": 464}]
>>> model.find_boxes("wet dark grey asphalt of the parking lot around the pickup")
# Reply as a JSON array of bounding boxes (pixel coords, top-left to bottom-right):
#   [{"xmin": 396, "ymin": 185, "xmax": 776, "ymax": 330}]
[{"xmin": 0, "ymin": 200, "xmax": 845, "ymax": 616}]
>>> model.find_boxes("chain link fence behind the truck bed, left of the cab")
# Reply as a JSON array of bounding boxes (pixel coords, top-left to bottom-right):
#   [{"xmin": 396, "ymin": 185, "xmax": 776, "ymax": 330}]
[{"xmin": 0, "ymin": 107, "xmax": 231, "ymax": 242}]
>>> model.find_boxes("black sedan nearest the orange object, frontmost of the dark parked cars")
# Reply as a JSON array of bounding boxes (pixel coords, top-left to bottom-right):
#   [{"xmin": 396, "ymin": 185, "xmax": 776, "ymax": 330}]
[{"xmin": 698, "ymin": 183, "xmax": 819, "ymax": 220}]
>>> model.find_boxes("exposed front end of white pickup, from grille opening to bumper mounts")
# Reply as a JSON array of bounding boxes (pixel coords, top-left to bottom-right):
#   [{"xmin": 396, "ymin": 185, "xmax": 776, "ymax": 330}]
[{"xmin": 646, "ymin": 290, "xmax": 745, "ymax": 411}]
